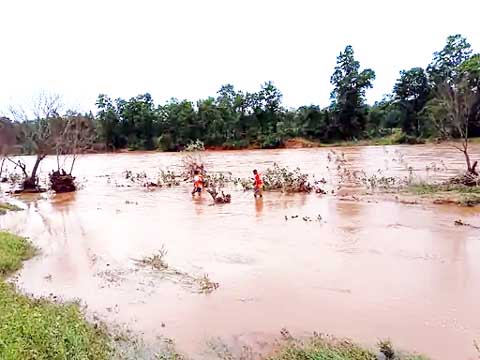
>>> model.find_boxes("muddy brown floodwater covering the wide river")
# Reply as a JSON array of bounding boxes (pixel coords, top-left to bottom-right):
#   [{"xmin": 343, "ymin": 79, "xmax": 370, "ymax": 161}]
[{"xmin": 0, "ymin": 145, "xmax": 480, "ymax": 359}]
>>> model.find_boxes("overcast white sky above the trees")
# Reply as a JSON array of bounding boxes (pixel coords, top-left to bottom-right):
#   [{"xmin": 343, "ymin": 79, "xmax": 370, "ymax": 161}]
[{"xmin": 0, "ymin": 0, "xmax": 480, "ymax": 110}]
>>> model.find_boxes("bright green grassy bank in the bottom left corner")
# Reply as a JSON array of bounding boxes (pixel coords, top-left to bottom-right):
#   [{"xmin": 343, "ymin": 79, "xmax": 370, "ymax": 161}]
[{"xmin": 0, "ymin": 232, "xmax": 112, "ymax": 360}]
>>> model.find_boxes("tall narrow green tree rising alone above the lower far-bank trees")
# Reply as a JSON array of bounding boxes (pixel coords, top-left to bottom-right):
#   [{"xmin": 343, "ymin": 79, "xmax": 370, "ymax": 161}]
[{"xmin": 330, "ymin": 45, "xmax": 375, "ymax": 138}]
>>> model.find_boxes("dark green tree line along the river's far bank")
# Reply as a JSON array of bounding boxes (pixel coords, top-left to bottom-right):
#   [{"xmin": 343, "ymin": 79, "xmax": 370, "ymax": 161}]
[{"xmin": 0, "ymin": 34, "xmax": 480, "ymax": 153}]
